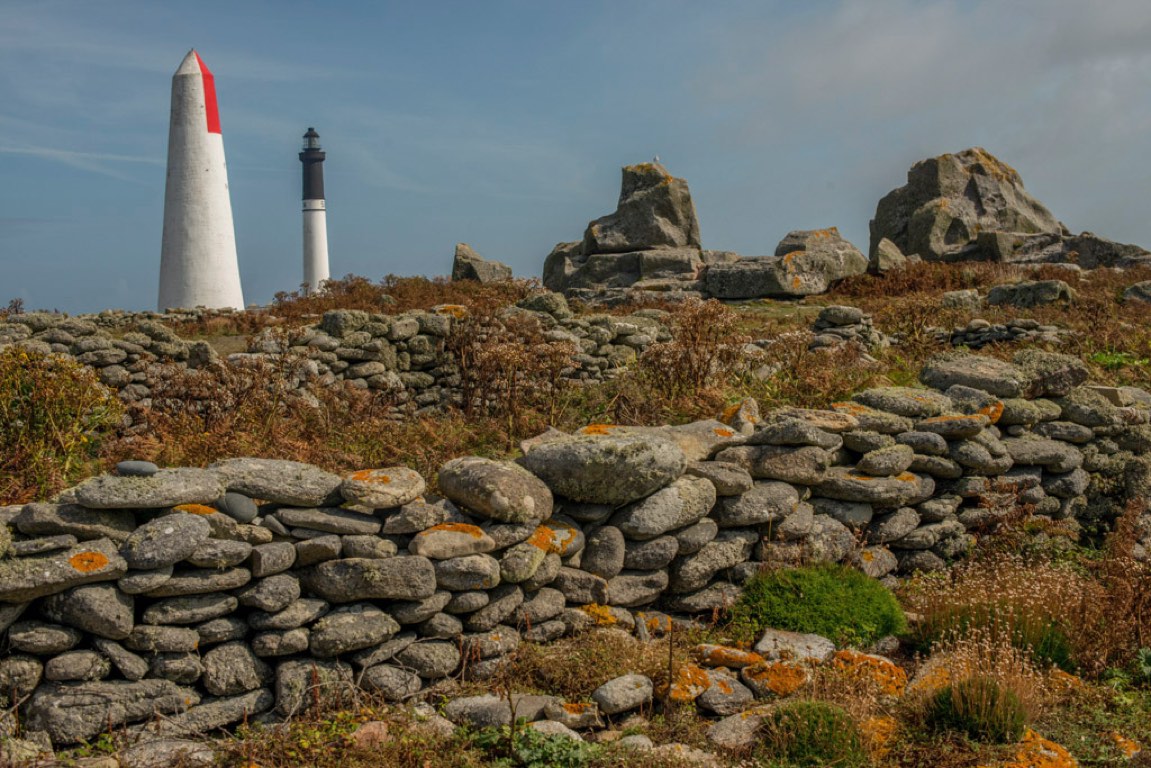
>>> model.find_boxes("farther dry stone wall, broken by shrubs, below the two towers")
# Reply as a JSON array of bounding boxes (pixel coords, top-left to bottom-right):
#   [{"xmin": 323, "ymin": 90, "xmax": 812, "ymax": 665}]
[{"xmin": 0, "ymin": 294, "xmax": 671, "ymax": 426}]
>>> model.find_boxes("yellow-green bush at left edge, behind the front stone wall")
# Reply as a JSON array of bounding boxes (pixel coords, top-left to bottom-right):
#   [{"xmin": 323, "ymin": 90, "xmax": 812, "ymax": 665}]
[{"xmin": 0, "ymin": 347, "xmax": 123, "ymax": 504}]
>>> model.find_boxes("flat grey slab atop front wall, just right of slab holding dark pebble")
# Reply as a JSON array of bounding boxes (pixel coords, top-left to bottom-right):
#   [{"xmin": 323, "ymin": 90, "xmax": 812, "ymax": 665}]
[{"xmin": 208, "ymin": 458, "xmax": 342, "ymax": 507}]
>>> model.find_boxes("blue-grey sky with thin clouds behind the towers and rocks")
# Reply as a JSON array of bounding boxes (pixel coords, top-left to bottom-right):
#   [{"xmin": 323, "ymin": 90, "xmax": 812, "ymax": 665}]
[{"xmin": 0, "ymin": 0, "xmax": 1151, "ymax": 313}]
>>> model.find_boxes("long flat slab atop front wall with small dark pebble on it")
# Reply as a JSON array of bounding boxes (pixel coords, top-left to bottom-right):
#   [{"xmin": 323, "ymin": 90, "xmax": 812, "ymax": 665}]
[{"xmin": 73, "ymin": 469, "xmax": 223, "ymax": 509}]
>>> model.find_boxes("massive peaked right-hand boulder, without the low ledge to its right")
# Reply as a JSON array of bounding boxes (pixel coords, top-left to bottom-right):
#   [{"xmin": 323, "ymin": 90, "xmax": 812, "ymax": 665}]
[{"xmin": 870, "ymin": 147, "xmax": 1062, "ymax": 261}]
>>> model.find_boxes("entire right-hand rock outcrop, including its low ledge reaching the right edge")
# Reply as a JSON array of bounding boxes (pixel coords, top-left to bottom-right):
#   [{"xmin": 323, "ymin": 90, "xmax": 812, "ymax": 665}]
[{"xmin": 869, "ymin": 147, "xmax": 1151, "ymax": 269}]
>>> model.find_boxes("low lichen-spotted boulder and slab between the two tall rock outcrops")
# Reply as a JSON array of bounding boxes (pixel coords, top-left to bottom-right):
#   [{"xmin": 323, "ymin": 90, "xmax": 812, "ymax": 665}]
[{"xmin": 707, "ymin": 227, "xmax": 868, "ymax": 299}]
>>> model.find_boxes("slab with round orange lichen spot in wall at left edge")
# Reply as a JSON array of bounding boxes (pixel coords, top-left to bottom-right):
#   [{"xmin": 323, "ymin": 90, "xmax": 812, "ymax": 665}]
[{"xmin": 0, "ymin": 539, "xmax": 128, "ymax": 602}]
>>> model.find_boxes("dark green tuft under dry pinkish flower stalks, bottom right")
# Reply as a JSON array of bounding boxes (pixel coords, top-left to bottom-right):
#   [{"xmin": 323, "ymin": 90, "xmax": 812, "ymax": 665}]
[{"xmin": 928, "ymin": 676, "xmax": 1027, "ymax": 744}]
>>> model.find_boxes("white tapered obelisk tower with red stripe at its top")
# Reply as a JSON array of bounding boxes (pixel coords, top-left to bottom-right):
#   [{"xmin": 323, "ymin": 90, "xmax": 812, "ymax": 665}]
[{"xmin": 157, "ymin": 51, "xmax": 244, "ymax": 312}]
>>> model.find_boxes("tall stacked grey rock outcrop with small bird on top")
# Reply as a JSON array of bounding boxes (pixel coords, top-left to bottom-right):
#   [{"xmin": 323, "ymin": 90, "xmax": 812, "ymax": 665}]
[{"xmin": 543, "ymin": 161, "xmax": 703, "ymax": 292}]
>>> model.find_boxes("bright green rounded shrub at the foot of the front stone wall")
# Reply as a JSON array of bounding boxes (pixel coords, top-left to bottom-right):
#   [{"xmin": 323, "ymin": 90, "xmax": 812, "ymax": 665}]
[{"xmin": 730, "ymin": 564, "xmax": 907, "ymax": 645}]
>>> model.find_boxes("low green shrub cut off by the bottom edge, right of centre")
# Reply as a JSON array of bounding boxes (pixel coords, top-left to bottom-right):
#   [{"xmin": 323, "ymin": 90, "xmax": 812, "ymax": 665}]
[{"xmin": 762, "ymin": 700, "xmax": 868, "ymax": 768}]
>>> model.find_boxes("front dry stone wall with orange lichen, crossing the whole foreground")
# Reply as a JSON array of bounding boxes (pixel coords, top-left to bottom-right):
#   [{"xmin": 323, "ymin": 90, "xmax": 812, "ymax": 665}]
[{"xmin": 0, "ymin": 351, "xmax": 1151, "ymax": 744}]
